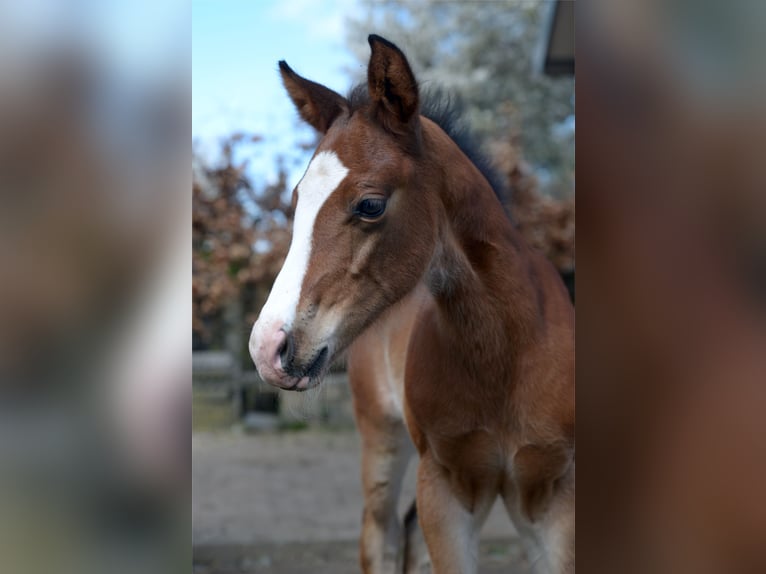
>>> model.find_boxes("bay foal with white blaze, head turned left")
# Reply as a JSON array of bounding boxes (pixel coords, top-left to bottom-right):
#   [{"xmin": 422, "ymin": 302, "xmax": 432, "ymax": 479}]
[{"xmin": 249, "ymin": 35, "xmax": 575, "ymax": 574}]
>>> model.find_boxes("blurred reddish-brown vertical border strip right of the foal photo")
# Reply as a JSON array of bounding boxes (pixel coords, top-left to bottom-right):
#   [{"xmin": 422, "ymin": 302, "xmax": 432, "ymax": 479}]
[{"xmin": 576, "ymin": 0, "xmax": 766, "ymax": 573}]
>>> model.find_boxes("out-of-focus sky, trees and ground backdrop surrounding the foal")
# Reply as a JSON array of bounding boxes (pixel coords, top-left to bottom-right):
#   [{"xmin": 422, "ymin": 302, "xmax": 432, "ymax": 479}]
[{"xmin": 192, "ymin": 0, "xmax": 575, "ymax": 573}]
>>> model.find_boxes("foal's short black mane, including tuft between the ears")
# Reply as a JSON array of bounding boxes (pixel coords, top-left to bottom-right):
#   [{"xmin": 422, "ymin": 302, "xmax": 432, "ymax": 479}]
[{"xmin": 347, "ymin": 84, "xmax": 508, "ymax": 205}]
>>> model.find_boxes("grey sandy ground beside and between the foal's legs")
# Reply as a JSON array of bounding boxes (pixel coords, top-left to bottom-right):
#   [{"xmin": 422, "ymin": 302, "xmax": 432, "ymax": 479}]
[{"xmin": 192, "ymin": 425, "xmax": 529, "ymax": 574}]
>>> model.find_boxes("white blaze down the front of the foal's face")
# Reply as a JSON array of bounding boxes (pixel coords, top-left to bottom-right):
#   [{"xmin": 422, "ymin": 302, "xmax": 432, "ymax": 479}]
[{"xmin": 250, "ymin": 151, "xmax": 348, "ymax": 336}]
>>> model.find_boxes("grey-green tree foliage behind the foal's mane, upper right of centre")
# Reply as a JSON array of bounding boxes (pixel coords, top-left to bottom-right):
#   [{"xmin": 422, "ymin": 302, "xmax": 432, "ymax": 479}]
[{"xmin": 348, "ymin": 0, "xmax": 574, "ymax": 196}]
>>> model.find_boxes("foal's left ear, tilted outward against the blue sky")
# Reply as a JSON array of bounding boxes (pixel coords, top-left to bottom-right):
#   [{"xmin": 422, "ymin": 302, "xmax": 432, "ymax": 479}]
[{"xmin": 279, "ymin": 60, "xmax": 348, "ymax": 133}]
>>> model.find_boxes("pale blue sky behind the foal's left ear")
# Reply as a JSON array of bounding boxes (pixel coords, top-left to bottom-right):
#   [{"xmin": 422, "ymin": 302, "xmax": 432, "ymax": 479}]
[{"xmin": 192, "ymin": 0, "xmax": 361, "ymax": 185}]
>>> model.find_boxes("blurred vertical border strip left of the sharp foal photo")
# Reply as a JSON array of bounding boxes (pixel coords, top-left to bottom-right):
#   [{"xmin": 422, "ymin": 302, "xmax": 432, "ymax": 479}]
[{"xmin": 0, "ymin": 0, "xmax": 191, "ymax": 574}]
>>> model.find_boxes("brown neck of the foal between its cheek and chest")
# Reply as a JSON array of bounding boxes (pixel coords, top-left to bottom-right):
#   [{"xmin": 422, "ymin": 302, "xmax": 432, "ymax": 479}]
[{"xmin": 424, "ymin": 122, "xmax": 541, "ymax": 356}]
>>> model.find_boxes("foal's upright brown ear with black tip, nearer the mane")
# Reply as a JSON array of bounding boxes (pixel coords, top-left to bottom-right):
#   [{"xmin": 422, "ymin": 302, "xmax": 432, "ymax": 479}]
[{"xmin": 367, "ymin": 34, "xmax": 419, "ymax": 130}]
